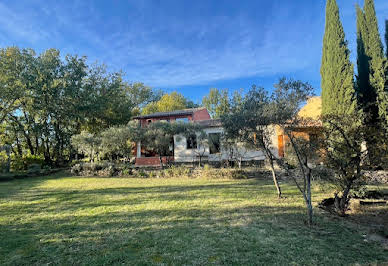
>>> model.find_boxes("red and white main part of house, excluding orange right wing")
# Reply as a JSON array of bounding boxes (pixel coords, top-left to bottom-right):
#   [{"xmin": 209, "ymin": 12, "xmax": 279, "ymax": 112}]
[{"xmin": 134, "ymin": 108, "xmax": 277, "ymax": 166}]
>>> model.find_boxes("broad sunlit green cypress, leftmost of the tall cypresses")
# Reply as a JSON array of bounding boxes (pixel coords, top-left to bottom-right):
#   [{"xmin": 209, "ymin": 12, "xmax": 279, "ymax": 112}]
[{"xmin": 321, "ymin": 0, "xmax": 356, "ymax": 115}]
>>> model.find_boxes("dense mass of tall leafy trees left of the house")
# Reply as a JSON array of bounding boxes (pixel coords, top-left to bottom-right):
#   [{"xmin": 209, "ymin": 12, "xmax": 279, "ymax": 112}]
[{"xmin": 0, "ymin": 47, "xmax": 157, "ymax": 165}]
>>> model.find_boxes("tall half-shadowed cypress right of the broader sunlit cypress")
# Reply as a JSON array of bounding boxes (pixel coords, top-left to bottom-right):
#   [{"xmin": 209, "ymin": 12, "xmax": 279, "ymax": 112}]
[{"xmin": 357, "ymin": 0, "xmax": 388, "ymax": 165}]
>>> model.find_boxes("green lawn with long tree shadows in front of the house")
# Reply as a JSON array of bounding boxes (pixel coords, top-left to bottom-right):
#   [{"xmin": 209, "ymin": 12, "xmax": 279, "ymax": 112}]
[{"xmin": 0, "ymin": 176, "xmax": 388, "ymax": 265}]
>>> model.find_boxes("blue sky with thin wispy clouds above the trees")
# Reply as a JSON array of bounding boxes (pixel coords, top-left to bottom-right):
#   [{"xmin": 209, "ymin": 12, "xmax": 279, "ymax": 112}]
[{"xmin": 0, "ymin": 0, "xmax": 388, "ymax": 101}]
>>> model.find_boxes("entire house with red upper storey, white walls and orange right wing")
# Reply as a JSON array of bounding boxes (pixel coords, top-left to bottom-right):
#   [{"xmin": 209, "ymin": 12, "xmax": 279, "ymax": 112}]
[{"xmin": 134, "ymin": 97, "xmax": 322, "ymax": 166}]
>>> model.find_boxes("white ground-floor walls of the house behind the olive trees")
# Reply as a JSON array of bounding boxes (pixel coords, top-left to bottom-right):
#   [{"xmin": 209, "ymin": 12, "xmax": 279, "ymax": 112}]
[{"xmin": 174, "ymin": 127, "xmax": 278, "ymax": 162}]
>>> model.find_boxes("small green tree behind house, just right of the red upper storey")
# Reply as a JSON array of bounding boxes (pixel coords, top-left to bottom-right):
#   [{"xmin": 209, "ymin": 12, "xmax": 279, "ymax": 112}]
[{"xmin": 202, "ymin": 88, "xmax": 230, "ymax": 118}]
